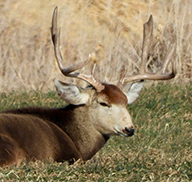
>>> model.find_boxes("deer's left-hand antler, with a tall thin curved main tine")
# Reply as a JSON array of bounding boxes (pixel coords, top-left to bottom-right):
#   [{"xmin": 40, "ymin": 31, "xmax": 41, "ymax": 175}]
[{"xmin": 51, "ymin": 7, "xmax": 104, "ymax": 92}]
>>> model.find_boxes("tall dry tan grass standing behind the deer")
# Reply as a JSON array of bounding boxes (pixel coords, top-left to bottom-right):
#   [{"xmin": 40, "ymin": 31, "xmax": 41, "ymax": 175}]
[{"xmin": 0, "ymin": 0, "xmax": 192, "ymax": 92}]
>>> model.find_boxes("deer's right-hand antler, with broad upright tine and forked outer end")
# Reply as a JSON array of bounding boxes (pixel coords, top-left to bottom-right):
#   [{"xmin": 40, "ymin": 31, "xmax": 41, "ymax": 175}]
[{"xmin": 117, "ymin": 15, "xmax": 176, "ymax": 89}]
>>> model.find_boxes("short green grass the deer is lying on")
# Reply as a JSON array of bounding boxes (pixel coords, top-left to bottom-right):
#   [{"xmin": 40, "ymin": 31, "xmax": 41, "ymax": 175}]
[{"xmin": 0, "ymin": 83, "xmax": 192, "ymax": 182}]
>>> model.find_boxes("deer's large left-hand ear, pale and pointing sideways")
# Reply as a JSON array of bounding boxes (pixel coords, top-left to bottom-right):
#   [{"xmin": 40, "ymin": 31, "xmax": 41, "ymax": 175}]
[{"xmin": 55, "ymin": 80, "xmax": 90, "ymax": 105}]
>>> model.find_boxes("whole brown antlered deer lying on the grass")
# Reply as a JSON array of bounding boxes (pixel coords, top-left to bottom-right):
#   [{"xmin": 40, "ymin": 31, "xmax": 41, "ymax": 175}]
[{"xmin": 0, "ymin": 7, "xmax": 176, "ymax": 166}]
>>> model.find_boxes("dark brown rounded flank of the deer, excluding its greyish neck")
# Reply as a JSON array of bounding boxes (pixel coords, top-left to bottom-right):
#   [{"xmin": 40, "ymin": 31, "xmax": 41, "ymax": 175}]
[{"xmin": 0, "ymin": 109, "xmax": 81, "ymax": 165}]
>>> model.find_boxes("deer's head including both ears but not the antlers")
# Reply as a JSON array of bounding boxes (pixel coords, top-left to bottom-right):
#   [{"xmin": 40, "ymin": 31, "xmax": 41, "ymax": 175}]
[{"xmin": 55, "ymin": 80, "xmax": 143, "ymax": 136}]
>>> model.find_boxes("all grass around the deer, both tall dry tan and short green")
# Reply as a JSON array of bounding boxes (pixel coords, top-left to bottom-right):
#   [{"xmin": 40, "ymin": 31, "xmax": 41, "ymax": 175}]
[{"xmin": 0, "ymin": 0, "xmax": 192, "ymax": 182}]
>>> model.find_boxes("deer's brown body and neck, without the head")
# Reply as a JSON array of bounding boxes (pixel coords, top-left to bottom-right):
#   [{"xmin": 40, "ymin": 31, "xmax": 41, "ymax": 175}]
[{"xmin": 0, "ymin": 105, "xmax": 108, "ymax": 166}]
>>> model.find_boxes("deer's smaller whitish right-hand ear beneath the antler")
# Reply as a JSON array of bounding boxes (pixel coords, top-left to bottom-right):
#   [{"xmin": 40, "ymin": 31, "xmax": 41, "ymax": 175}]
[{"xmin": 125, "ymin": 81, "xmax": 144, "ymax": 104}]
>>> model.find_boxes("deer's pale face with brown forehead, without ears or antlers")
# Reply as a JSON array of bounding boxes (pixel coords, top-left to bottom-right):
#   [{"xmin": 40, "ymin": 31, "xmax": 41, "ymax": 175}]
[{"xmin": 94, "ymin": 84, "xmax": 134, "ymax": 136}]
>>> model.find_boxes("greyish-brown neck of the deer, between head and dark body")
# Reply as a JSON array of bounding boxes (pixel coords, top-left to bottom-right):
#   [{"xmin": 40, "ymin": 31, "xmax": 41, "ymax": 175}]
[{"xmin": 62, "ymin": 106, "xmax": 109, "ymax": 160}]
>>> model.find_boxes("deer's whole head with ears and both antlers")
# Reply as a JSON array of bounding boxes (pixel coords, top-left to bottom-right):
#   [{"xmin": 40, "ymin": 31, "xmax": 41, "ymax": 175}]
[{"xmin": 51, "ymin": 7, "xmax": 176, "ymax": 136}]
